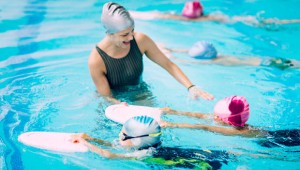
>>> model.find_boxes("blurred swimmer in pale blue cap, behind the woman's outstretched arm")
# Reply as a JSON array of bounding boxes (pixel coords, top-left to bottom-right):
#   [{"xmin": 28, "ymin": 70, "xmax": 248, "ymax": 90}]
[{"xmin": 158, "ymin": 41, "xmax": 300, "ymax": 70}]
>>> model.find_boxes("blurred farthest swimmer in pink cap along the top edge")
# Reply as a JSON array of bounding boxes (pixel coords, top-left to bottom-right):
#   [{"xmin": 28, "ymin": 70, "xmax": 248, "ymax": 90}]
[{"xmin": 129, "ymin": 1, "xmax": 300, "ymax": 27}]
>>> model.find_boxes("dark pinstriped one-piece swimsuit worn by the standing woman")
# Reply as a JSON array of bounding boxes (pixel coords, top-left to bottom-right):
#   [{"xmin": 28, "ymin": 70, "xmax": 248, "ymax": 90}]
[{"xmin": 96, "ymin": 38, "xmax": 143, "ymax": 89}]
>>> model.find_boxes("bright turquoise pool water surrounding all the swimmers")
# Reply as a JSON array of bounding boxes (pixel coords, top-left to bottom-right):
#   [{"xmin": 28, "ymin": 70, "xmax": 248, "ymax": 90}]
[{"xmin": 0, "ymin": 0, "xmax": 300, "ymax": 169}]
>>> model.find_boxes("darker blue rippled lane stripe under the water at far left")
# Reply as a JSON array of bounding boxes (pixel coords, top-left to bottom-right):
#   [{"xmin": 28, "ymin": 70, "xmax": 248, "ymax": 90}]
[{"xmin": 1, "ymin": 1, "xmax": 47, "ymax": 169}]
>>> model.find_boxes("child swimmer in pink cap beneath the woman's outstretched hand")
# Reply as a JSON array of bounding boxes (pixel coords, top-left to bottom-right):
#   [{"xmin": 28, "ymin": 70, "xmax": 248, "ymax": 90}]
[{"xmin": 162, "ymin": 96, "xmax": 300, "ymax": 147}]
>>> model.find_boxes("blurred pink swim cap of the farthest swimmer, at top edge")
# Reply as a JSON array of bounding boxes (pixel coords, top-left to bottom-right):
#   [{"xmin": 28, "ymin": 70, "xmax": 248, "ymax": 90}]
[{"xmin": 182, "ymin": 0, "xmax": 203, "ymax": 18}]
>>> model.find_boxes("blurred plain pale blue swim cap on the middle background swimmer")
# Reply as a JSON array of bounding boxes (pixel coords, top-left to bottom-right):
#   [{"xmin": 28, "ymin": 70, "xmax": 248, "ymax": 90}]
[{"xmin": 188, "ymin": 41, "xmax": 217, "ymax": 59}]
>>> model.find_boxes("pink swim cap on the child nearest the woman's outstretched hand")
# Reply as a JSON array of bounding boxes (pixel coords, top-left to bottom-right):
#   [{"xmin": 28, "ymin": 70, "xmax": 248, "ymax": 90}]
[{"xmin": 214, "ymin": 96, "xmax": 250, "ymax": 126}]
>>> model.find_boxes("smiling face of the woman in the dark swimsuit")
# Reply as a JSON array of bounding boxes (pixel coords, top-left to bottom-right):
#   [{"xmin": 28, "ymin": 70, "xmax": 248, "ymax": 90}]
[{"xmin": 109, "ymin": 28, "xmax": 134, "ymax": 48}]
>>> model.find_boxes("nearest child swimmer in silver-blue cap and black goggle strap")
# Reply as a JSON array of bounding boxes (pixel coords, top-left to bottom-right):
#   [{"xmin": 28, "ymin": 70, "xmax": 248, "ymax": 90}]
[{"xmin": 71, "ymin": 116, "xmax": 282, "ymax": 169}]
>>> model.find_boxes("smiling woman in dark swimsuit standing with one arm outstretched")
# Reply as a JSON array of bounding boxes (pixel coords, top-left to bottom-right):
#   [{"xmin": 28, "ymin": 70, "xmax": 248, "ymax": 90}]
[{"xmin": 88, "ymin": 2, "xmax": 214, "ymax": 103}]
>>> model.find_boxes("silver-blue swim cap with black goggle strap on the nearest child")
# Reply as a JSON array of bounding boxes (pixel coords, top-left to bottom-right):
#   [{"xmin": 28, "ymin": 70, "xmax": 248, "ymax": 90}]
[{"xmin": 123, "ymin": 116, "xmax": 161, "ymax": 149}]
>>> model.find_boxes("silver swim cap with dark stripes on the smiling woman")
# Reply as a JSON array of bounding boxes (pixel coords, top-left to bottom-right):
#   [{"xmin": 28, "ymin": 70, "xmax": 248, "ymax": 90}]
[{"xmin": 101, "ymin": 2, "xmax": 134, "ymax": 34}]
